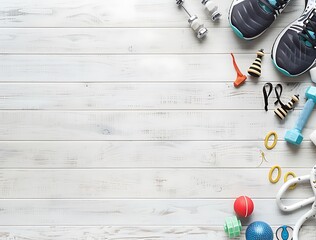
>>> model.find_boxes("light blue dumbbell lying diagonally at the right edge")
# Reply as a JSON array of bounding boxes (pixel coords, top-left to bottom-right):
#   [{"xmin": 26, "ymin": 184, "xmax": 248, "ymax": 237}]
[{"xmin": 284, "ymin": 87, "xmax": 316, "ymax": 145}]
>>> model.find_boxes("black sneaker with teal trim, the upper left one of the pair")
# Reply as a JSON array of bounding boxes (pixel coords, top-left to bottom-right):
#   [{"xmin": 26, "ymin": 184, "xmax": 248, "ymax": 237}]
[{"xmin": 228, "ymin": 0, "xmax": 290, "ymax": 40}]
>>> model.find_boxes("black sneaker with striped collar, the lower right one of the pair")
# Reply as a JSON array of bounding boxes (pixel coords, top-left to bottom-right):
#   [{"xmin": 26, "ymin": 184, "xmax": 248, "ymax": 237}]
[{"xmin": 271, "ymin": 0, "xmax": 316, "ymax": 77}]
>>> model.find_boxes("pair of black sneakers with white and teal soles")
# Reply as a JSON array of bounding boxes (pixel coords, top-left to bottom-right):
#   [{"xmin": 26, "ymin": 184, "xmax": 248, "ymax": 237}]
[{"xmin": 228, "ymin": 0, "xmax": 316, "ymax": 76}]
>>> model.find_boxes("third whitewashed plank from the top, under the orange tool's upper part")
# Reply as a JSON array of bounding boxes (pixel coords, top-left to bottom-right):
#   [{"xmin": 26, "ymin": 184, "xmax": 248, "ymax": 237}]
[{"xmin": 0, "ymin": 54, "xmax": 310, "ymax": 82}]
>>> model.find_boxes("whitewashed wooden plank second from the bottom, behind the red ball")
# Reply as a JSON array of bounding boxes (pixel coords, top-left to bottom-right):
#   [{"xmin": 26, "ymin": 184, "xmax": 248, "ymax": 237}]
[{"xmin": 0, "ymin": 199, "xmax": 315, "ymax": 225}]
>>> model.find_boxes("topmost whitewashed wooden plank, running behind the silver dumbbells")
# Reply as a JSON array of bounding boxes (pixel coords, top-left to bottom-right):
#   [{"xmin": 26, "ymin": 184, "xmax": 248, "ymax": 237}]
[{"xmin": 0, "ymin": 0, "xmax": 304, "ymax": 28}]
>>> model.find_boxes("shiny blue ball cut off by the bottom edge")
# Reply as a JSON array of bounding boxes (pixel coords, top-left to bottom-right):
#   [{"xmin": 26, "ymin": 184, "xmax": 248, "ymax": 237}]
[{"xmin": 246, "ymin": 221, "xmax": 273, "ymax": 240}]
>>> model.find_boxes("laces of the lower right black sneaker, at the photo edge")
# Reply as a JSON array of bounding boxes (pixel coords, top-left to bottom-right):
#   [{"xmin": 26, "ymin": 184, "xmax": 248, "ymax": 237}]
[{"xmin": 299, "ymin": 9, "xmax": 316, "ymax": 48}]
